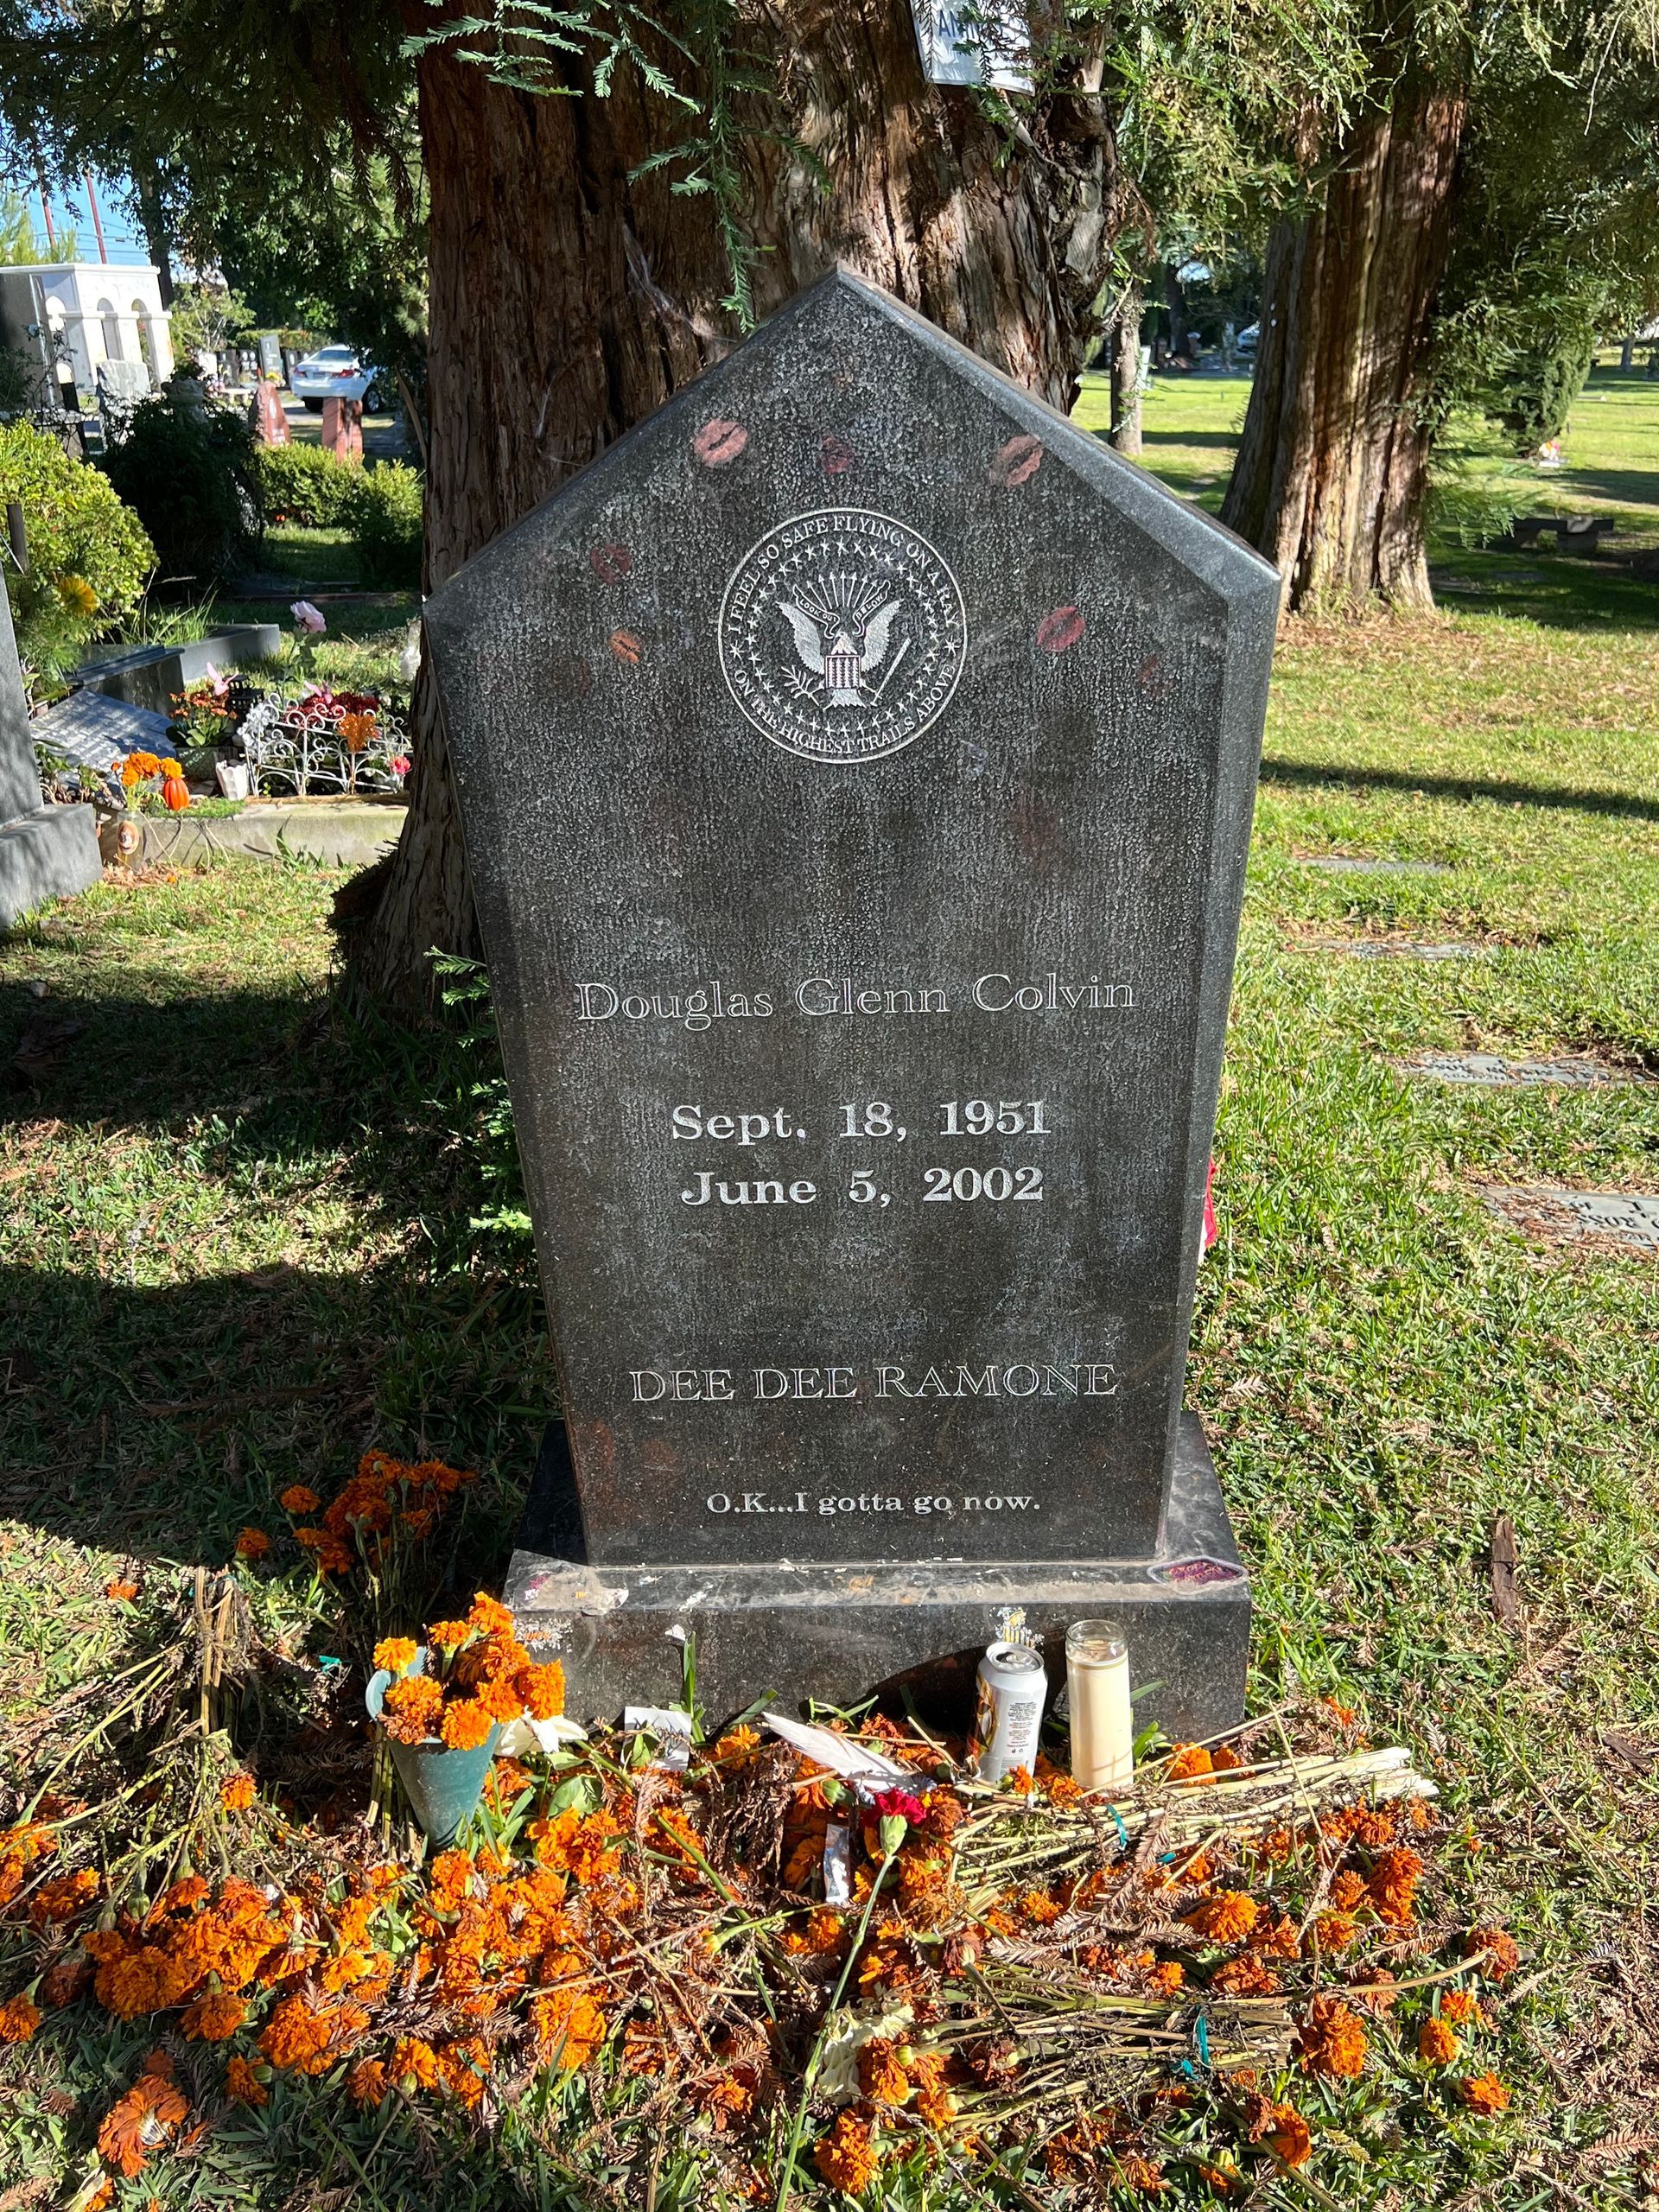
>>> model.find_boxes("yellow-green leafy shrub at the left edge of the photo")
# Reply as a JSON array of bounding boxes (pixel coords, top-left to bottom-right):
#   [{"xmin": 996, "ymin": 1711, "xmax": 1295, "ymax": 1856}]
[{"xmin": 0, "ymin": 423, "xmax": 155, "ymax": 675}]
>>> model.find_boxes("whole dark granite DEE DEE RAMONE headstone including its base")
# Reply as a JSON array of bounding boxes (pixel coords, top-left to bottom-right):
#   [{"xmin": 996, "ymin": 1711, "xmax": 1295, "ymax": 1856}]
[{"xmin": 427, "ymin": 274, "xmax": 1276, "ymax": 1726}]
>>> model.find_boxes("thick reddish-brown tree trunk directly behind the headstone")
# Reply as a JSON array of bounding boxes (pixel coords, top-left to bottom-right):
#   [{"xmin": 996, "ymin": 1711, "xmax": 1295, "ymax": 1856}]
[{"xmin": 339, "ymin": 0, "xmax": 1113, "ymax": 1011}]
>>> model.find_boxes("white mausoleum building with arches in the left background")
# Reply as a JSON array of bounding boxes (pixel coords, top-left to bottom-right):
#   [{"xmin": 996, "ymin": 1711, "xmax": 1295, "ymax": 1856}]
[{"xmin": 0, "ymin": 261, "xmax": 173, "ymax": 403}]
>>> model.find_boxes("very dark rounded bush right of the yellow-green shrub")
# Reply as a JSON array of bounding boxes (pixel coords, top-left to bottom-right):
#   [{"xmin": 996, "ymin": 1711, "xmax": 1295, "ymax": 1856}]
[{"xmin": 104, "ymin": 380, "xmax": 265, "ymax": 584}]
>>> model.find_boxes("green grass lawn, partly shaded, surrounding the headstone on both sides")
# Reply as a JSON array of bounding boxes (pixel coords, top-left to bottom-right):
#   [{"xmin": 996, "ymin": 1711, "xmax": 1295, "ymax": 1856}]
[{"xmin": 0, "ymin": 372, "xmax": 1659, "ymax": 2212}]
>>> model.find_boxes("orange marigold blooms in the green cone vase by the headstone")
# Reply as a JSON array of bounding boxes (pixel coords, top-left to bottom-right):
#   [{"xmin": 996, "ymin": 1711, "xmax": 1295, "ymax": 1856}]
[{"xmin": 374, "ymin": 1591, "xmax": 564, "ymax": 1752}]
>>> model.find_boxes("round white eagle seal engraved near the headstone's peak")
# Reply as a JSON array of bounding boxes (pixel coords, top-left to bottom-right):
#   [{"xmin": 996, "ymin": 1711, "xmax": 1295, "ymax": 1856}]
[{"xmin": 719, "ymin": 506, "xmax": 967, "ymax": 763}]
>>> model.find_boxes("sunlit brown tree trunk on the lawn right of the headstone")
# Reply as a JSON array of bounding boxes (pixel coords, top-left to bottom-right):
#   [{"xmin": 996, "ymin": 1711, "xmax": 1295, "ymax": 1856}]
[{"xmin": 1221, "ymin": 93, "xmax": 1465, "ymax": 608}]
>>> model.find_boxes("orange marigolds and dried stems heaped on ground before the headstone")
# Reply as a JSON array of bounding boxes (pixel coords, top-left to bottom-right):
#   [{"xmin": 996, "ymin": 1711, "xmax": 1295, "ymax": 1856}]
[{"xmin": 0, "ymin": 1689, "xmax": 1517, "ymax": 2203}]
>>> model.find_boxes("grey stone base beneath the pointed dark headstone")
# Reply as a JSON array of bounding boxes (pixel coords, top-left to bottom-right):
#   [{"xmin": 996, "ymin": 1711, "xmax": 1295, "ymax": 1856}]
[{"xmin": 506, "ymin": 1414, "xmax": 1249, "ymax": 1741}]
